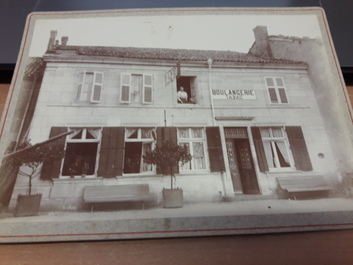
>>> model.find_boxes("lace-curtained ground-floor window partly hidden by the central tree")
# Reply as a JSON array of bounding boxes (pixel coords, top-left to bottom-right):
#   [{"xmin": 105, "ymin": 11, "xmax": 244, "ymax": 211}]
[{"xmin": 178, "ymin": 128, "xmax": 207, "ymax": 171}]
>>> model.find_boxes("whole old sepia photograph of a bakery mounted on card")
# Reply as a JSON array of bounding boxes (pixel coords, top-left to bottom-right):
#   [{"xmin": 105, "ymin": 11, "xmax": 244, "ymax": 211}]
[{"xmin": 0, "ymin": 8, "xmax": 353, "ymax": 242}]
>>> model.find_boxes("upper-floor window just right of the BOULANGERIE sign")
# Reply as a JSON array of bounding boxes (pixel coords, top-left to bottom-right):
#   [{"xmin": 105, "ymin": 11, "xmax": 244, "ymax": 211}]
[{"xmin": 266, "ymin": 77, "xmax": 288, "ymax": 104}]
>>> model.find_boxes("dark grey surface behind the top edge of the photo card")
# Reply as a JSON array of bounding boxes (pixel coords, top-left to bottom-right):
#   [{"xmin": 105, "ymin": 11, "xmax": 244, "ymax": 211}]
[{"xmin": 0, "ymin": 0, "xmax": 353, "ymax": 70}]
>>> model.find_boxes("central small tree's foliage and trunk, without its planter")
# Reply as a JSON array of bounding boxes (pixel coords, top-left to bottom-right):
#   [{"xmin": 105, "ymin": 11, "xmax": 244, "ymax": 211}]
[{"xmin": 143, "ymin": 141, "xmax": 192, "ymax": 189}]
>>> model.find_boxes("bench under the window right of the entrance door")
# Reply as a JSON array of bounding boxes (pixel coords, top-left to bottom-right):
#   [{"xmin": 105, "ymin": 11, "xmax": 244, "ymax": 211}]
[{"xmin": 277, "ymin": 175, "xmax": 331, "ymax": 199}]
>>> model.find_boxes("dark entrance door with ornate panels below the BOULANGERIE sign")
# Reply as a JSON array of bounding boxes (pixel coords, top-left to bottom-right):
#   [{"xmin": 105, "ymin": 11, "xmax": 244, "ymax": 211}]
[{"xmin": 225, "ymin": 128, "xmax": 260, "ymax": 194}]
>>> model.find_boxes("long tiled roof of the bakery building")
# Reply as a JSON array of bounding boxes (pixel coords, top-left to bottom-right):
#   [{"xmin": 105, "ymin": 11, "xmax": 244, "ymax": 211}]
[{"xmin": 46, "ymin": 46, "xmax": 300, "ymax": 64}]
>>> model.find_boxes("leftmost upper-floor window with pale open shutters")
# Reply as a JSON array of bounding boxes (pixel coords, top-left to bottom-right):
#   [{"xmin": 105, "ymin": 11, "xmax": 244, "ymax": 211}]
[{"xmin": 76, "ymin": 71, "xmax": 104, "ymax": 103}]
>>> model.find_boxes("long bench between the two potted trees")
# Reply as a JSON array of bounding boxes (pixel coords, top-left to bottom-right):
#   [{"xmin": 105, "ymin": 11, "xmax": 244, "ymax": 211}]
[{"xmin": 83, "ymin": 184, "xmax": 157, "ymax": 211}]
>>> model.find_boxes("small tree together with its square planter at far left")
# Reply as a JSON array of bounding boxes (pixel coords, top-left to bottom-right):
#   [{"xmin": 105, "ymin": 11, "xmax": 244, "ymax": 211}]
[{"xmin": 6, "ymin": 141, "xmax": 65, "ymax": 216}]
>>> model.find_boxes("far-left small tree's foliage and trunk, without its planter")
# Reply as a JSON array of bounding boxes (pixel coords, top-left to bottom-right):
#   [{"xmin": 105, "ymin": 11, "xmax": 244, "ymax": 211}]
[{"xmin": 6, "ymin": 141, "xmax": 65, "ymax": 195}]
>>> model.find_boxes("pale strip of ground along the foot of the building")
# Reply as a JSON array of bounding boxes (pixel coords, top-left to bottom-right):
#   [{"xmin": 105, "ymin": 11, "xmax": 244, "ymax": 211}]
[{"xmin": 0, "ymin": 195, "xmax": 353, "ymax": 224}]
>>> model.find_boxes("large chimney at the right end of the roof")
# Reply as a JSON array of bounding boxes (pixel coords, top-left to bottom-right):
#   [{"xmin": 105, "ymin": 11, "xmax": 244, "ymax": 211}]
[{"xmin": 249, "ymin": 26, "xmax": 272, "ymax": 58}]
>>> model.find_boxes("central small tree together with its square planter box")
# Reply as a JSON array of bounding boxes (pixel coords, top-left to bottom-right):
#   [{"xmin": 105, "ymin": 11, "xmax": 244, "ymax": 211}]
[{"xmin": 143, "ymin": 141, "xmax": 192, "ymax": 208}]
